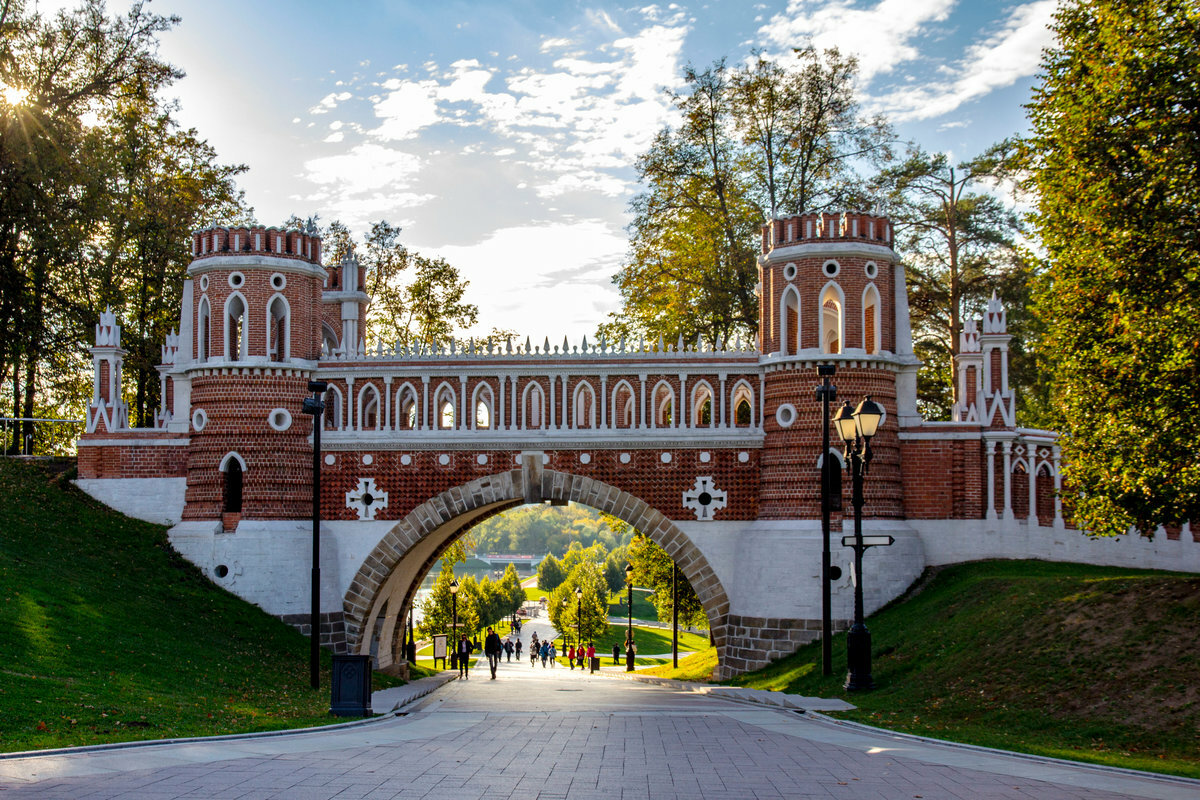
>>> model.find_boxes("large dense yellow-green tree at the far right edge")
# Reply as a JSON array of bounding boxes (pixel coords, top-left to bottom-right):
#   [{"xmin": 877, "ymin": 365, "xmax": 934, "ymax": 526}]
[{"xmin": 1028, "ymin": 0, "xmax": 1200, "ymax": 534}]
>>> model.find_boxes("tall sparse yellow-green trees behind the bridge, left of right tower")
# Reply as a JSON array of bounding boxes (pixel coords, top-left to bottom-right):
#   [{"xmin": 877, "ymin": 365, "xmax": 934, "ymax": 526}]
[{"xmin": 600, "ymin": 49, "xmax": 892, "ymax": 347}]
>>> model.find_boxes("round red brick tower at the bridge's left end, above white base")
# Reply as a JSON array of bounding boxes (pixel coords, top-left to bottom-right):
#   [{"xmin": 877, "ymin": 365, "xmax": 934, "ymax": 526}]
[{"xmin": 176, "ymin": 221, "xmax": 328, "ymax": 530}]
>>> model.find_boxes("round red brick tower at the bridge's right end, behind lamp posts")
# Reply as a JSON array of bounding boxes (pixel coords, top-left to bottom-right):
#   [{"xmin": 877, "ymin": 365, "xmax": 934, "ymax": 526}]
[{"xmin": 758, "ymin": 212, "xmax": 917, "ymax": 519}]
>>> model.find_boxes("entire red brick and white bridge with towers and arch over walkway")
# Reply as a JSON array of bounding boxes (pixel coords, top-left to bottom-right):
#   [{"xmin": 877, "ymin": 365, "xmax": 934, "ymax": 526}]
[{"xmin": 79, "ymin": 213, "xmax": 1200, "ymax": 675}]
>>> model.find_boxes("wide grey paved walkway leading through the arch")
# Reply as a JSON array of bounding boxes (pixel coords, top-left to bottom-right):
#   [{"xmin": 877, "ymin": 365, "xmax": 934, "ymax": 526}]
[{"xmin": 0, "ymin": 647, "xmax": 1200, "ymax": 800}]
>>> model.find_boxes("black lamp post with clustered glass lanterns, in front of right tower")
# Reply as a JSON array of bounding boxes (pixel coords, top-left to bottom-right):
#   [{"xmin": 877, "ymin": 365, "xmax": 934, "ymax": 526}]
[{"xmin": 833, "ymin": 396, "xmax": 883, "ymax": 691}]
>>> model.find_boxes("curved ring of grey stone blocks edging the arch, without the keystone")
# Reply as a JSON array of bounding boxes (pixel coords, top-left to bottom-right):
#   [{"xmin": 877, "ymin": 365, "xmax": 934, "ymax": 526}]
[{"xmin": 343, "ymin": 469, "xmax": 730, "ymax": 669}]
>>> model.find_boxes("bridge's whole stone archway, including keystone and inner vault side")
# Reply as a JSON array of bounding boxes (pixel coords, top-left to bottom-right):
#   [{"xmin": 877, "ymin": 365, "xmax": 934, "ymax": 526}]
[{"xmin": 343, "ymin": 453, "xmax": 730, "ymax": 674}]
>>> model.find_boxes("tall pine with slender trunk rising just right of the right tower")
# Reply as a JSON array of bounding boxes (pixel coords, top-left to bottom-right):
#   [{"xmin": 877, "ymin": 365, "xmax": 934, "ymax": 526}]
[{"xmin": 876, "ymin": 142, "xmax": 1025, "ymax": 420}]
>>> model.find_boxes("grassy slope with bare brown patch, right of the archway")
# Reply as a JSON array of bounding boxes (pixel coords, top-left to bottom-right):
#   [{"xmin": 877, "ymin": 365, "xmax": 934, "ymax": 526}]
[{"xmin": 730, "ymin": 561, "xmax": 1200, "ymax": 777}]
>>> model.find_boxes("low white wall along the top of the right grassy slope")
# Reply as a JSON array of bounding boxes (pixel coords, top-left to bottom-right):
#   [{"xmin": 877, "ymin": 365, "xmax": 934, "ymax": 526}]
[{"xmin": 908, "ymin": 519, "xmax": 1200, "ymax": 572}]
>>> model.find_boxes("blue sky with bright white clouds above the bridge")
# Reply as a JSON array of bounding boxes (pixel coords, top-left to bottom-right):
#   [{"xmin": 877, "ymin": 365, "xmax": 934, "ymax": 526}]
[{"xmin": 38, "ymin": 0, "xmax": 1056, "ymax": 341}]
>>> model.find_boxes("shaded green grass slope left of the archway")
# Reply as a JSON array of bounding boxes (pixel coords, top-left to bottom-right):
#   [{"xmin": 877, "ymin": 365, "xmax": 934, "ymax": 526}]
[{"xmin": 0, "ymin": 459, "xmax": 402, "ymax": 752}]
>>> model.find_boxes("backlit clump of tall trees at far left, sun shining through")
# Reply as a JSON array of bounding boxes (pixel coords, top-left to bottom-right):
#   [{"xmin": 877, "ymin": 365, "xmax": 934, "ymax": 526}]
[{"xmin": 0, "ymin": 0, "xmax": 238, "ymax": 441}]
